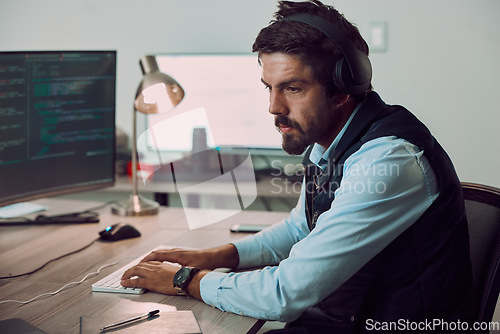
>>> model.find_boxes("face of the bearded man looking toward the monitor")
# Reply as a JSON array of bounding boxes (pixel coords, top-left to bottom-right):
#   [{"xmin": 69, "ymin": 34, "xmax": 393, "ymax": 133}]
[{"xmin": 260, "ymin": 53, "xmax": 348, "ymax": 154}]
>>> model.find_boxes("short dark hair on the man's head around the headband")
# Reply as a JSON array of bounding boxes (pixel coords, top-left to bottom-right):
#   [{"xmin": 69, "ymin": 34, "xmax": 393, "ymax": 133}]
[{"xmin": 252, "ymin": 0, "xmax": 369, "ymax": 98}]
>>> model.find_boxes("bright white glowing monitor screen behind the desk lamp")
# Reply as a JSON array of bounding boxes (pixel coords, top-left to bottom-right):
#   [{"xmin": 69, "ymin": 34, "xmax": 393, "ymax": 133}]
[{"xmin": 146, "ymin": 54, "xmax": 282, "ymax": 152}]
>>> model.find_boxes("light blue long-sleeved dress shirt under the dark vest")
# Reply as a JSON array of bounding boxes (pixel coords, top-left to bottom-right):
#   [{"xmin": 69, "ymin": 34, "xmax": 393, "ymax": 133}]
[{"xmin": 200, "ymin": 108, "xmax": 438, "ymax": 321}]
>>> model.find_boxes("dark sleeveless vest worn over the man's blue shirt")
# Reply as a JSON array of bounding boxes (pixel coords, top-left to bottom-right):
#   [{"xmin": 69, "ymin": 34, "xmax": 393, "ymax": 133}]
[{"xmin": 298, "ymin": 92, "xmax": 472, "ymax": 333}]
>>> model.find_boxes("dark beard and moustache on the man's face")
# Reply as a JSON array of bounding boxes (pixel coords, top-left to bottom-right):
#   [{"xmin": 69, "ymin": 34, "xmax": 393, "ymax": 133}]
[{"xmin": 274, "ymin": 115, "xmax": 319, "ymax": 155}]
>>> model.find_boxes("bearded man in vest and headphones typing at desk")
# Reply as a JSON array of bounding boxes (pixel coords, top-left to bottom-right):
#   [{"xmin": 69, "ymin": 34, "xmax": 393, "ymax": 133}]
[{"xmin": 122, "ymin": 0, "xmax": 472, "ymax": 333}]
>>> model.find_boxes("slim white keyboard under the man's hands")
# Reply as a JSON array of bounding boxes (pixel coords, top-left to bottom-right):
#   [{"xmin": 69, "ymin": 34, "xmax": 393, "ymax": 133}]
[{"xmin": 92, "ymin": 246, "xmax": 181, "ymax": 295}]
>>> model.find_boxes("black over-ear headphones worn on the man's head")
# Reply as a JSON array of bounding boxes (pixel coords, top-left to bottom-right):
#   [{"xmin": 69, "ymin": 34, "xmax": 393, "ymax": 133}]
[{"xmin": 282, "ymin": 13, "xmax": 372, "ymax": 95}]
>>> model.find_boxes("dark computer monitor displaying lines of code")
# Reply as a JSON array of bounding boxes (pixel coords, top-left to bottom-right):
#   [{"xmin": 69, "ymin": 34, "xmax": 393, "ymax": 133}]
[{"xmin": 0, "ymin": 51, "xmax": 116, "ymax": 207}]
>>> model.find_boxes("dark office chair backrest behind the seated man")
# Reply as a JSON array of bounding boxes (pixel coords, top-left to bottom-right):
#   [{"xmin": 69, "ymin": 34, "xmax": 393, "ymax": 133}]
[{"xmin": 462, "ymin": 183, "xmax": 500, "ymax": 333}]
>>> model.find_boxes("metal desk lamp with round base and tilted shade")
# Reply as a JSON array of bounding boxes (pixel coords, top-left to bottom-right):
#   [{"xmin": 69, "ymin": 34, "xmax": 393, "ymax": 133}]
[{"xmin": 111, "ymin": 56, "xmax": 184, "ymax": 216}]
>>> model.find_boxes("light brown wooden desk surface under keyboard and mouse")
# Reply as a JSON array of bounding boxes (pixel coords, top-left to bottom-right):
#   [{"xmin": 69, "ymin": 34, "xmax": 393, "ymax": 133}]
[{"xmin": 0, "ymin": 199, "xmax": 287, "ymax": 334}]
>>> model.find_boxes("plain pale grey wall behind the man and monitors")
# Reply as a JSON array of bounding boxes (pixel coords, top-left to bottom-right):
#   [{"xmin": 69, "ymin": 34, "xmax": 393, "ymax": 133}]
[{"xmin": 0, "ymin": 0, "xmax": 500, "ymax": 186}]
